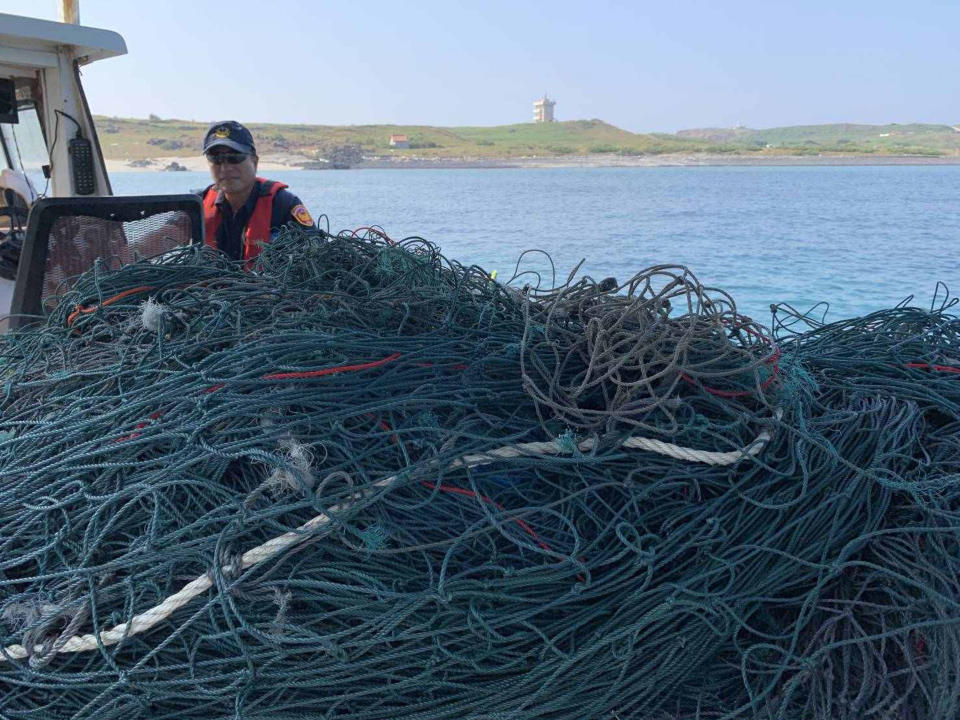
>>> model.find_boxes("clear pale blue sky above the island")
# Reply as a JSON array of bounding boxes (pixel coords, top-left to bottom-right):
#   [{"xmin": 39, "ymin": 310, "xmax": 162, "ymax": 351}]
[{"xmin": 0, "ymin": 0, "xmax": 960, "ymax": 132}]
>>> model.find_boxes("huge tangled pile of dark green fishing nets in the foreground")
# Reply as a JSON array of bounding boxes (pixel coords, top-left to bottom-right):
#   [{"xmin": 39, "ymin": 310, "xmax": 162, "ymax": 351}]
[{"xmin": 0, "ymin": 229, "xmax": 960, "ymax": 720}]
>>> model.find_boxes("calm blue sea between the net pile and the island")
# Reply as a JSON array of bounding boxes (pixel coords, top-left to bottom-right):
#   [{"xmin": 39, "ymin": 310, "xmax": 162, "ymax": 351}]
[{"xmin": 111, "ymin": 166, "xmax": 960, "ymax": 322}]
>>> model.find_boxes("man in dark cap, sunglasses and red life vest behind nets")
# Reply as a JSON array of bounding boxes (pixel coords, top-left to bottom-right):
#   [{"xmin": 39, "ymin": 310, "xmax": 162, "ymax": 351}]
[{"xmin": 200, "ymin": 120, "xmax": 313, "ymax": 263}]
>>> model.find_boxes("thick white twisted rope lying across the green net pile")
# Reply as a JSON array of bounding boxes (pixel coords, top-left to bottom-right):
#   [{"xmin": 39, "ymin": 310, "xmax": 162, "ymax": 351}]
[{"xmin": 0, "ymin": 410, "xmax": 782, "ymax": 660}]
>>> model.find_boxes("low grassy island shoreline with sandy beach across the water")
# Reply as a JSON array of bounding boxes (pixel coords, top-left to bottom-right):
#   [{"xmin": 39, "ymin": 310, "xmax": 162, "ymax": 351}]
[{"xmin": 96, "ymin": 116, "xmax": 960, "ymax": 167}]
